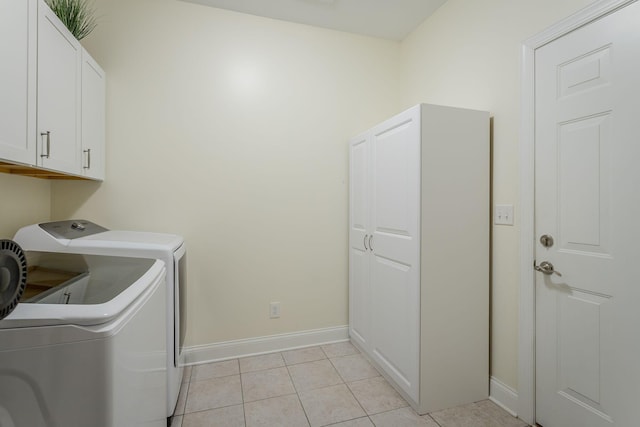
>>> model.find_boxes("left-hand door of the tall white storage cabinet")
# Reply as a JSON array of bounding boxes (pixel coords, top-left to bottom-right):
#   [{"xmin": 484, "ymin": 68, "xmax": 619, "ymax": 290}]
[{"xmin": 349, "ymin": 134, "xmax": 371, "ymax": 349}]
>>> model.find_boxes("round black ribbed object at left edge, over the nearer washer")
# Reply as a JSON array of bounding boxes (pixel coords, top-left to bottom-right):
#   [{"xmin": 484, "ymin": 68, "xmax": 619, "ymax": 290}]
[{"xmin": 0, "ymin": 240, "xmax": 27, "ymax": 319}]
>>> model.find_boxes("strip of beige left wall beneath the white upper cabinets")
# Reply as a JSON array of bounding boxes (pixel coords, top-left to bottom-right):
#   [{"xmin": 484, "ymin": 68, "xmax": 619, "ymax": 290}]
[{"xmin": 0, "ymin": 173, "xmax": 51, "ymax": 239}]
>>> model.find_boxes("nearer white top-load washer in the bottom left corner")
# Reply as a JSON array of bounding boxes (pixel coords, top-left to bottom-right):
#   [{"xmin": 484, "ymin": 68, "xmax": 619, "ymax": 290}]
[{"xmin": 0, "ymin": 251, "xmax": 167, "ymax": 427}]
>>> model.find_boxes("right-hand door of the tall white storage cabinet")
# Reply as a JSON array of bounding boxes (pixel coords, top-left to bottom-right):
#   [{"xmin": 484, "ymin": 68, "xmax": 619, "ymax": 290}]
[{"xmin": 370, "ymin": 106, "xmax": 421, "ymax": 401}]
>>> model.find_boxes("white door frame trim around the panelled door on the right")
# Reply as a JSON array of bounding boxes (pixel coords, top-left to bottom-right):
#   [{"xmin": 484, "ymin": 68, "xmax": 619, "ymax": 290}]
[{"xmin": 517, "ymin": 0, "xmax": 638, "ymax": 425}]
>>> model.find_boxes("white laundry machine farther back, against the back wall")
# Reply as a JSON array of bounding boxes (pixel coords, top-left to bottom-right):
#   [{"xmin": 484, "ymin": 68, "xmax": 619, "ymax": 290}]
[{"xmin": 14, "ymin": 220, "xmax": 187, "ymax": 417}]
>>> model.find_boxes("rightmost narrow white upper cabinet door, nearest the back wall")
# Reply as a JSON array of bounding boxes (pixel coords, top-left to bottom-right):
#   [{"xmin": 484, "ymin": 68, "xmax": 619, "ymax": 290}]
[{"xmin": 80, "ymin": 49, "xmax": 105, "ymax": 180}]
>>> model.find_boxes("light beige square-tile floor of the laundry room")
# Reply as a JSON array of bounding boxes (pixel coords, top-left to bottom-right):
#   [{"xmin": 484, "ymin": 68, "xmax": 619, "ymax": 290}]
[{"xmin": 171, "ymin": 342, "xmax": 527, "ymax": 427}]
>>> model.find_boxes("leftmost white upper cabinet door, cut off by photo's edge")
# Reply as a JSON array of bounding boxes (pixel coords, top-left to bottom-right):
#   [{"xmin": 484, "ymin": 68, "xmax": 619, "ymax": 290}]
[{"xmin": 0, "ymin": 0, "xmax": 38, "ymax": 164}]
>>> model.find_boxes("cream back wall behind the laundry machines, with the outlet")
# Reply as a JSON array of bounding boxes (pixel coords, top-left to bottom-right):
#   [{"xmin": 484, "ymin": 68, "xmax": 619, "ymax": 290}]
[{"xmin": 52, "ymin": 0, "xmax": 400, "ymax": 345}]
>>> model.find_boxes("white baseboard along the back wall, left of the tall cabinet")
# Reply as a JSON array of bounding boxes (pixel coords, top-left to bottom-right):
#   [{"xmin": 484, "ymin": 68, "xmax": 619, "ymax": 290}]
[{"xmin": 183, "ymin": 326, "xmax": 349, "ymax": 365}]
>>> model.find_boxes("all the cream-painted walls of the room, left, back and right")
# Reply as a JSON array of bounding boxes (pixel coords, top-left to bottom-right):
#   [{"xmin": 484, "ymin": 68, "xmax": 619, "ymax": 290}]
[{"xmin": 0, "ymin": 0, "xmax": 591, "ymax": 396}]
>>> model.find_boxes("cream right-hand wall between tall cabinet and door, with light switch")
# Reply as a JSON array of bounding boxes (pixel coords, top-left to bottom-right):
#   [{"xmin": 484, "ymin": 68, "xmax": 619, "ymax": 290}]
[{"xmin": 401, "ymin": 0, "xmax": 592, "ymax": 388}]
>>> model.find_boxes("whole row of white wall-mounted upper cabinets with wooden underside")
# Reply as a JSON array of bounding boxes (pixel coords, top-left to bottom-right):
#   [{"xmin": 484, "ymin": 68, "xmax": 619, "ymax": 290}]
[{"xmin": 0, "ymin": 0, "xmax": 105, "ymax": 180}]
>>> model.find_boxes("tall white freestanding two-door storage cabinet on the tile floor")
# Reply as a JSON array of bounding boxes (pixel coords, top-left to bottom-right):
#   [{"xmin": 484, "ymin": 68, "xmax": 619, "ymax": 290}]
[{"xmin": 349, "ymin": 104, "xmax": 490, "ymax": 414}]
